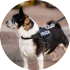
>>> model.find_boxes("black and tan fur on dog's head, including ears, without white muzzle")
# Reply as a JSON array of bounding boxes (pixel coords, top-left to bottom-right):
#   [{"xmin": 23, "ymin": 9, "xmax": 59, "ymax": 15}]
[{"xmin": 12, "ymin": 7, "xmax": 34, "ymax": 30}]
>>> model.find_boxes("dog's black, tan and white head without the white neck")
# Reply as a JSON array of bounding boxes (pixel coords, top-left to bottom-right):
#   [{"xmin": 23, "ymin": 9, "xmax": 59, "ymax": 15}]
[{"xmin": 6, "ymin": 7, "xmax": 33, "ymax": 30}]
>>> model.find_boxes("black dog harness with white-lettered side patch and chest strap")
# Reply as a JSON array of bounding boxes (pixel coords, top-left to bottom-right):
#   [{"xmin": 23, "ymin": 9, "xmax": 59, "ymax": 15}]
[{"xmin": 21, "ymin": 27, "xmax": 52, "ymax": 49}]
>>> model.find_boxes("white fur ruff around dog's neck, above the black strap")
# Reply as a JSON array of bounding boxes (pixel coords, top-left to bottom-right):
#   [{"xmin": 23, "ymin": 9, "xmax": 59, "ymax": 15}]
[{"xmin": 15, "ymin": 18, "xmax": 39, "ymax": 38}]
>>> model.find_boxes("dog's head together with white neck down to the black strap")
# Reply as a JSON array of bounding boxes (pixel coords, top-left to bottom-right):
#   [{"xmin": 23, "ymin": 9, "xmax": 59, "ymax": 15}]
[{"xmin": 6, "ymin": 7, "xmax": 39, "ymax": 37}]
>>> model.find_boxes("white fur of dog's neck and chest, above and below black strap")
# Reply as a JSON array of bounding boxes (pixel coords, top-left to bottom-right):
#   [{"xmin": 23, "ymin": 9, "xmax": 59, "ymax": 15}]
[{"xmin": 17, "ymin": 18, "xmax": 39, "ymax": 57}]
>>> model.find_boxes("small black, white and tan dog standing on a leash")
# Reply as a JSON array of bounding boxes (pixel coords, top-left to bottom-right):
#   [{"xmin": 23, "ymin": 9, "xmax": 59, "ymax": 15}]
[{"xmin": 6, "ymin": 7, "xmax": 69, "ymax": 70}]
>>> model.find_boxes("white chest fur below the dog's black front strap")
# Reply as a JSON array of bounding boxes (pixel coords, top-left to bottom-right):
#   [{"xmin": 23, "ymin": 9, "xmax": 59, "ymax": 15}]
[{"xmin": 19, "ymin": 38, "xmax": 35, "ymax": 58}]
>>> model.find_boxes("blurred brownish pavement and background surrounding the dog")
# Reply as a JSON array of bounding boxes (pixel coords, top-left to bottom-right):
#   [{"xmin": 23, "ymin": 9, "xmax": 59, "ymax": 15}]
[{"xmin": 0, "ymin": 0, "xmax": 70, "ymax": 70}]
